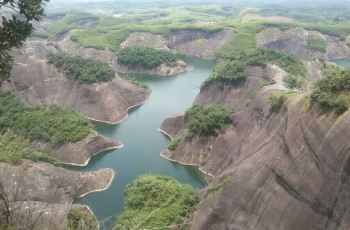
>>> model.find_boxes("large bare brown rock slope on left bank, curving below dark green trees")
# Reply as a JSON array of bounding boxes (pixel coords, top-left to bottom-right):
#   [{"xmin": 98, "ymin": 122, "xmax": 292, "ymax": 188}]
[{"xmin": 11, "ymin": 39, "xmax": 147, "ymax": 123}]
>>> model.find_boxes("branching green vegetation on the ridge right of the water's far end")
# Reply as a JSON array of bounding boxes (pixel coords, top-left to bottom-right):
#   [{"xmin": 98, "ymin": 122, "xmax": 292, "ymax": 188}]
[{"xmin": 209, "ymin": 21, "xmax": 306, "ymax": 88}]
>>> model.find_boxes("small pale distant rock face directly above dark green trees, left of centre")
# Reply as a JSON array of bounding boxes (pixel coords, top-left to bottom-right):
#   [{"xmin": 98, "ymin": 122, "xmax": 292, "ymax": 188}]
[{"xmin": 120, "ymin": 32, "xmax": 169, "ymax": 50}]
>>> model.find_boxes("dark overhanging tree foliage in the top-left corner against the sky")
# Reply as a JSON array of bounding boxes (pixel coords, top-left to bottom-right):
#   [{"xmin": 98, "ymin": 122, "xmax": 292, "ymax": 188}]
[{"xmin": 0, "ymin": 0, "xmax": 49, "ymax": 84}]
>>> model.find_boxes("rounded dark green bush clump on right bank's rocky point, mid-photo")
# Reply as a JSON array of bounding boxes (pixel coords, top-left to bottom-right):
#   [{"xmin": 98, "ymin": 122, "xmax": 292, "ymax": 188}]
[{"xmin": 185, "ymin": 105, "xmax": 233, "ymax": 137}]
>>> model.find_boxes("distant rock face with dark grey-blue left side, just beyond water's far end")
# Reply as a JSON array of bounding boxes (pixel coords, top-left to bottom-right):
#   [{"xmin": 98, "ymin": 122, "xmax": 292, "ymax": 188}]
[{"xmin": 168, "ymin": 28, "xmax": 233, "ymax": 59}]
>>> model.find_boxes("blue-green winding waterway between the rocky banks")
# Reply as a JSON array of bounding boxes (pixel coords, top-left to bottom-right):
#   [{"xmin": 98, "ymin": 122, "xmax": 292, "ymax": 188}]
[{"xmin": 76, "ymin": 57, "xmax": 213, "ymax": 227}]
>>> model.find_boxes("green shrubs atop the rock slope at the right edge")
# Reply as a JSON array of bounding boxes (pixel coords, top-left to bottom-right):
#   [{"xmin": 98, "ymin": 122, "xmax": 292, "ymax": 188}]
[{"xmin": 311, "ymin": 66, "xmax": 350, "ymax": 115}]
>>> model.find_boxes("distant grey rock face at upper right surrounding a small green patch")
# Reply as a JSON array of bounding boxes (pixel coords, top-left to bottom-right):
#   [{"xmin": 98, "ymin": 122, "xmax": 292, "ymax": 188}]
[{"xmin": 257, "ymin": 27, "xmax": 350, "ymax": 60}]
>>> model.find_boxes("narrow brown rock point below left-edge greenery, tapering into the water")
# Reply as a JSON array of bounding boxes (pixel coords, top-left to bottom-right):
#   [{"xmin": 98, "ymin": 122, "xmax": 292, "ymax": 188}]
[{"xmin": 33, "ymin": 131, "xmax": 123, "ymax": 166}]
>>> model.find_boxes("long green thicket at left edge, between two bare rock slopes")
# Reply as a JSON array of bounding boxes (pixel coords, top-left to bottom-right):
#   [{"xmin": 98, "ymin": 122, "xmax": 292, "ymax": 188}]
[{"xmin": 0, "ymin": 93, "xmax": 92, "ymax": 143}]
